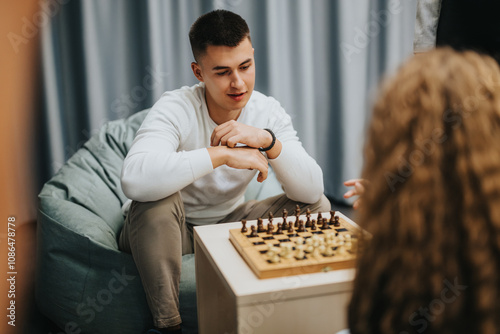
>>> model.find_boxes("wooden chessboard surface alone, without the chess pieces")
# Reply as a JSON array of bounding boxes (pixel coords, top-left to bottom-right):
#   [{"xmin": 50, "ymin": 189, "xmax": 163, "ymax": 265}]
[{"xmin": 229, "ymin": 211, "xmax": 361, "ymax": 278}]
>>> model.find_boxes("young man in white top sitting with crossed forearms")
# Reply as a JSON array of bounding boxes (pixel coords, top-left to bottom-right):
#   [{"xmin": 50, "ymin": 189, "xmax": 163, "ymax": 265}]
[{"xmin": 120, "ymin": 10, "xmax": 330, "ymax": 333}]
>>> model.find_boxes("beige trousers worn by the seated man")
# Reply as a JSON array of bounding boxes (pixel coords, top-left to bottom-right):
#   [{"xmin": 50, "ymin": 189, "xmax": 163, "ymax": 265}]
[{"xmin": 119, "ymin": 193, "xmax": 330, "ymax": 328}]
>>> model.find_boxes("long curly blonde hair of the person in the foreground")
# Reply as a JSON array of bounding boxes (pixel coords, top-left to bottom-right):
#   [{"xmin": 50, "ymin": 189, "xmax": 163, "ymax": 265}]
[{"xmin": 349, "ymin": 48, "xmax": 500, "ymax": 334}]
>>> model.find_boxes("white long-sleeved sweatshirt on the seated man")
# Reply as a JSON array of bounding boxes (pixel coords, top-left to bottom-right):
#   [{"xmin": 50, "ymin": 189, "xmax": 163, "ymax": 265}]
[{"xmin": 121, "ymin": 83, "xmax": 323, "ymax": 225}]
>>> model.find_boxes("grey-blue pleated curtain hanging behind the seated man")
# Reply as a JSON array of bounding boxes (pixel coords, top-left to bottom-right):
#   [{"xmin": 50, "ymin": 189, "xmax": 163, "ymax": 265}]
[{"xmin": 42, "ymin": 0, "xmax": 416, "ymax": 201}]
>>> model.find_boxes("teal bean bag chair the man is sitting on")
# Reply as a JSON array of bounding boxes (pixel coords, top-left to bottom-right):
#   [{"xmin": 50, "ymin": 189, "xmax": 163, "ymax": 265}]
[{"xmin": 35, "ymin": 110, "xmax": 282, "ymax": 334}]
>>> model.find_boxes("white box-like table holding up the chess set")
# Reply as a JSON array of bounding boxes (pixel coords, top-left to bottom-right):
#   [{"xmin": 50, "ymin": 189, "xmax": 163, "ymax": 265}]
[{"xmin": 194, "ymin": 215, "xmax": 354, "ymax": 334}]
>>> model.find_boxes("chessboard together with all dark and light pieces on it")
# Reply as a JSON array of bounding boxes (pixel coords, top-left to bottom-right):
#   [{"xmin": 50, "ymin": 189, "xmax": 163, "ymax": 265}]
[{"xmin": 229, "ymin": 207, "xmax": 361, "ymax": 278}]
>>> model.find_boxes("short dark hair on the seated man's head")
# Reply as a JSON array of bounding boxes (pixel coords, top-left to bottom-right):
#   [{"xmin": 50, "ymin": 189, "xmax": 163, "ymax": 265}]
[{"xmin": 189, "ymin": 9, "xmax": 250, "ymax": 61}]
